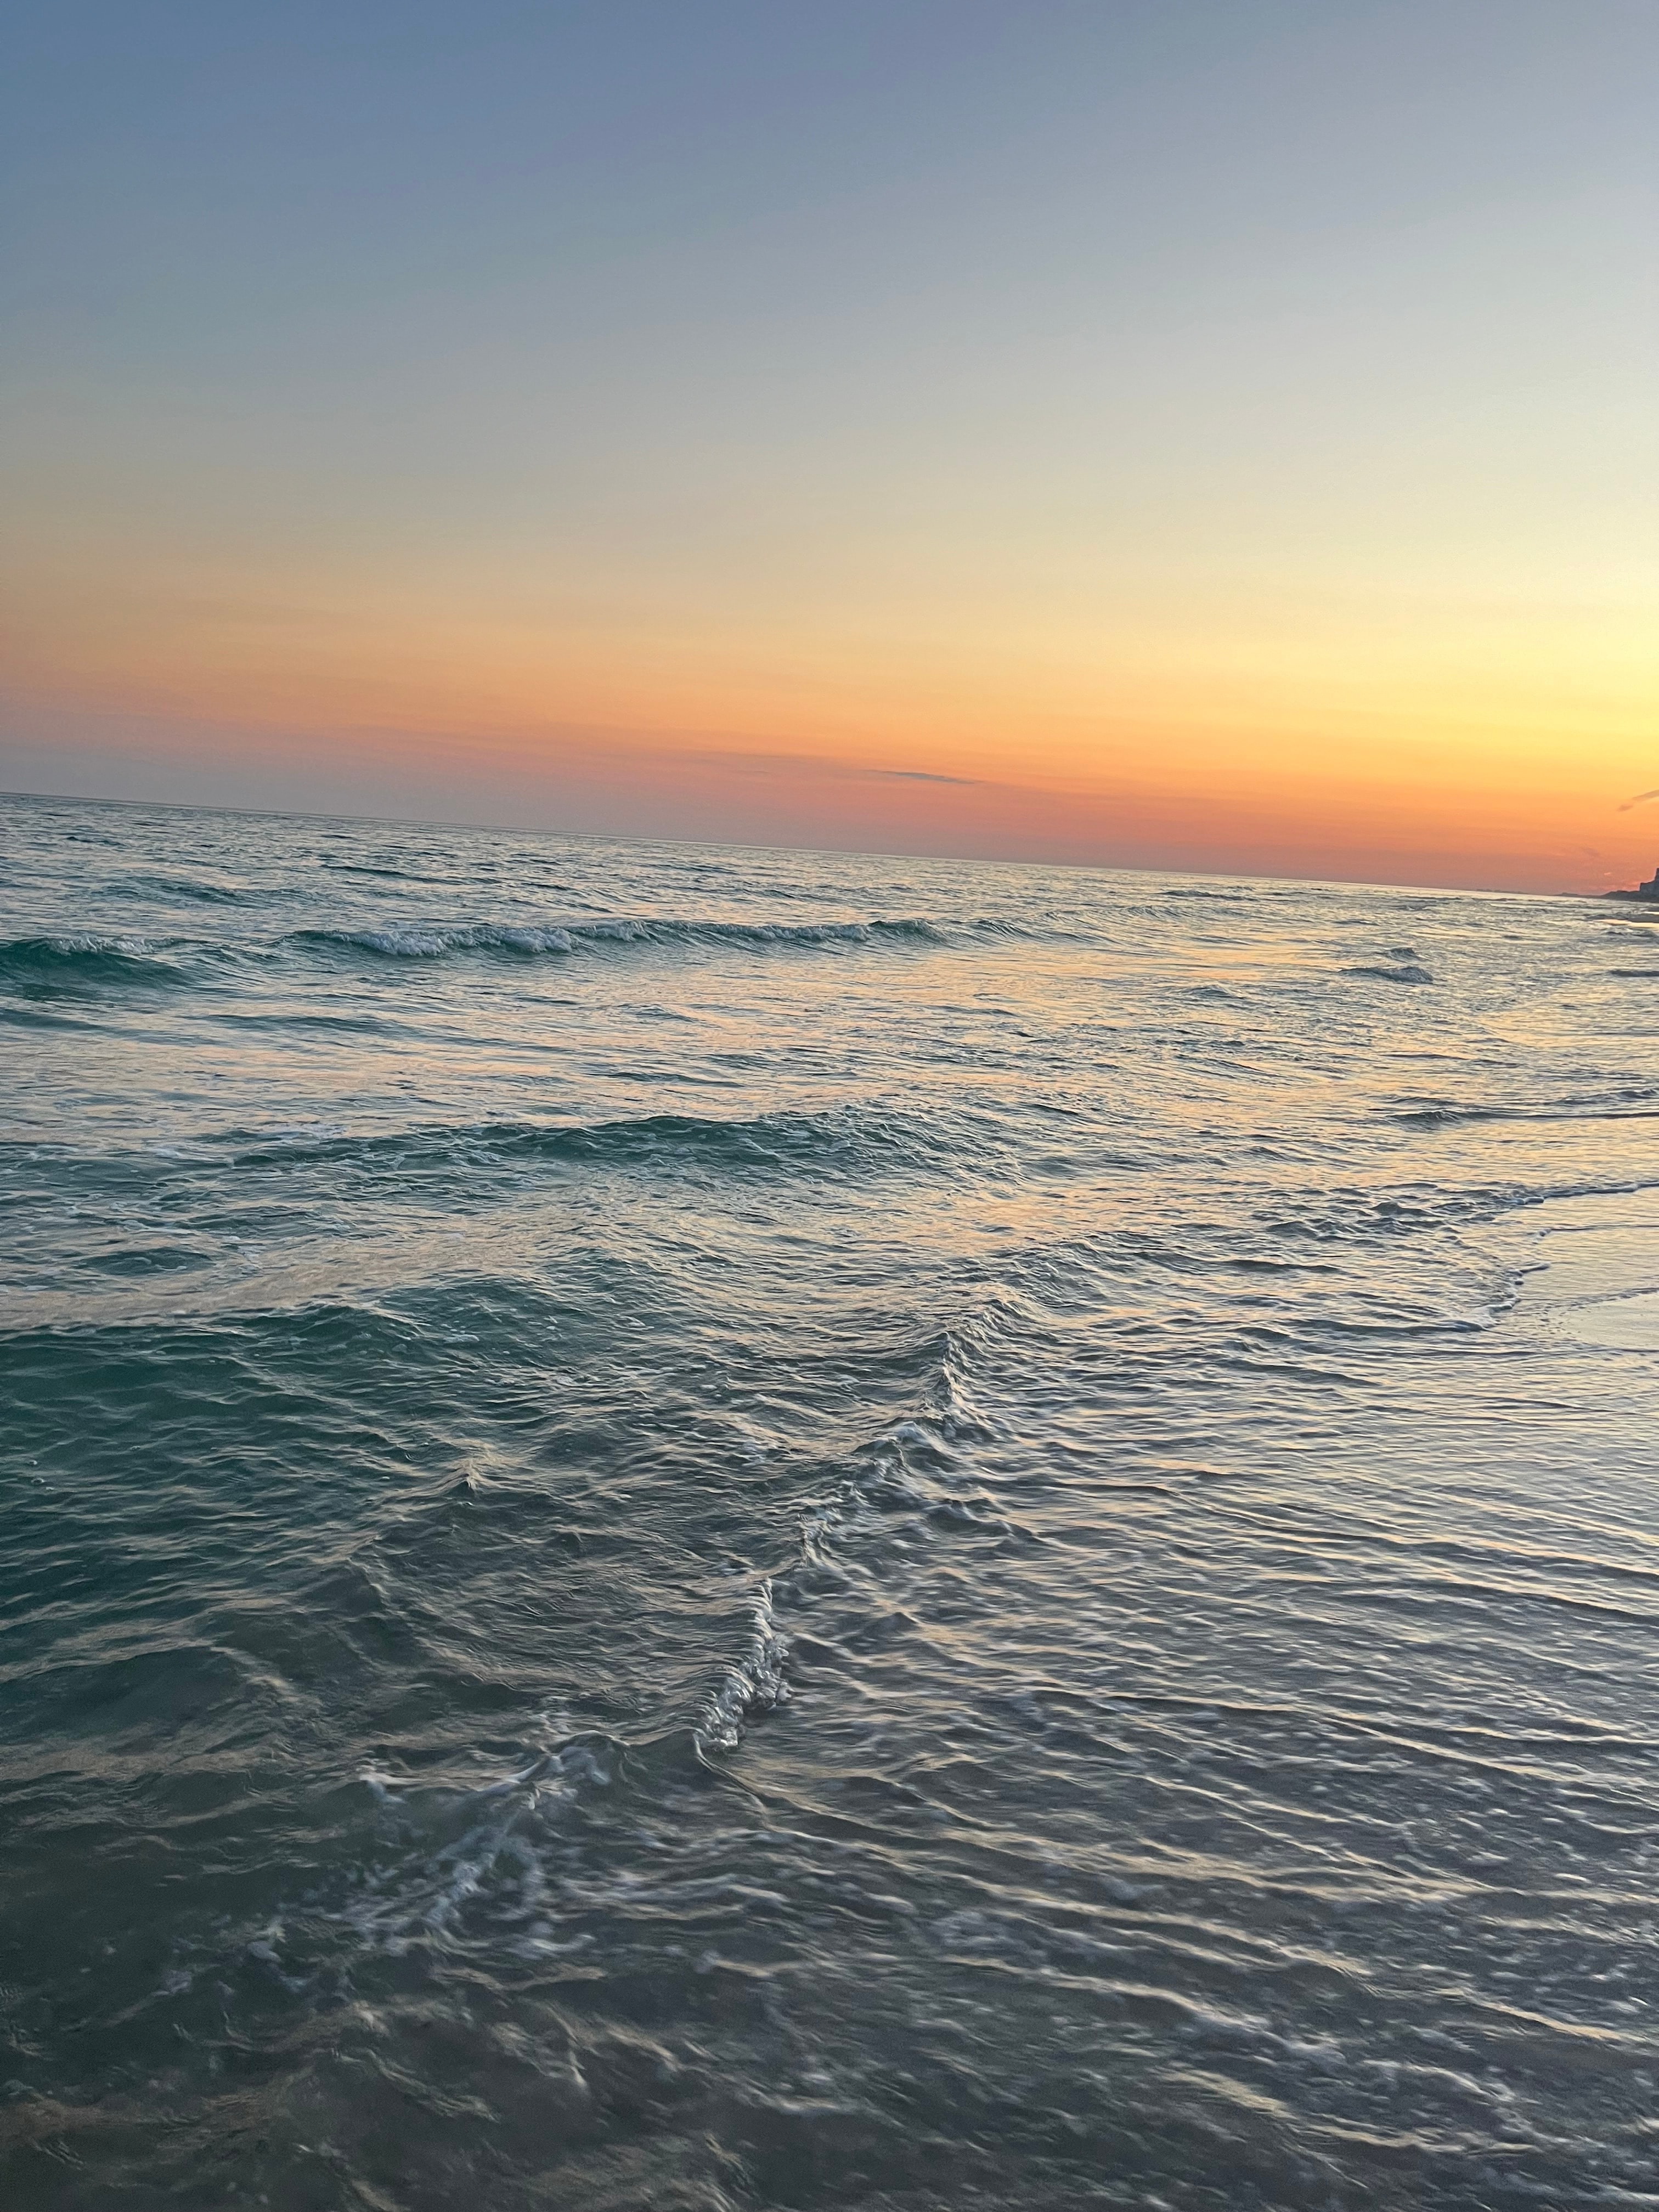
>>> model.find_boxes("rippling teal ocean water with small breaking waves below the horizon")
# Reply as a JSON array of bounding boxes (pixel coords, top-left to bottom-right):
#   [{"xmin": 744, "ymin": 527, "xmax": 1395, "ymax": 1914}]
[{"xmin": 0, "ymin": 799, "xmax": 1659, "ymax": 2212}]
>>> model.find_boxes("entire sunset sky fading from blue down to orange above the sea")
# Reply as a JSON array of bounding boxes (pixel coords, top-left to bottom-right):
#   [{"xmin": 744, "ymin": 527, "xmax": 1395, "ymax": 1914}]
[{"xmin": 0, "ymin": 0, "xmax": 1659, "ymax": 891}]
